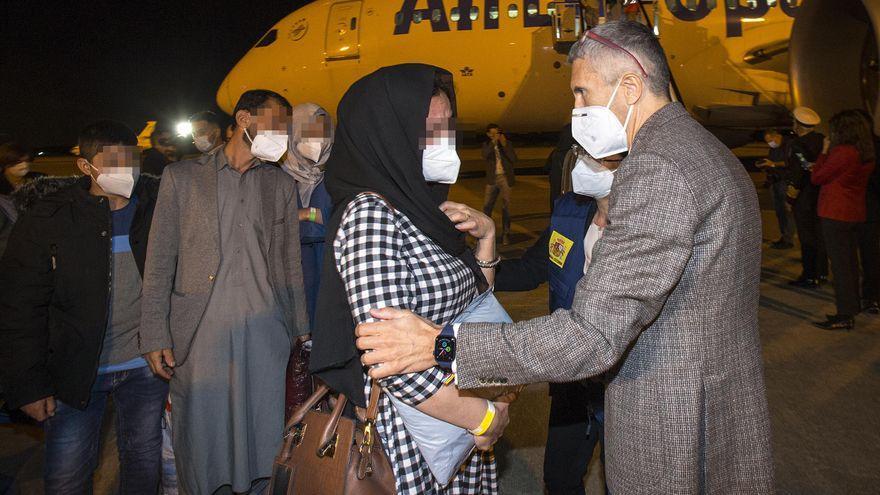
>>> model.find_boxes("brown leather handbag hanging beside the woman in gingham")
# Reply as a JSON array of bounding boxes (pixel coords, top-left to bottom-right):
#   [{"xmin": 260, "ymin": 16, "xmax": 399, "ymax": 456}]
[{"xmin": 268, "ymin": 382, "xmax": 395, "ymax": 495}]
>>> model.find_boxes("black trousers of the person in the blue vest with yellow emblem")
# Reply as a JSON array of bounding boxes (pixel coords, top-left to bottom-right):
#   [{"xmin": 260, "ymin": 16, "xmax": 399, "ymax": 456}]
[{"xmin": 544, "ymin": 383, "xmax": 605, "ymax": 495}]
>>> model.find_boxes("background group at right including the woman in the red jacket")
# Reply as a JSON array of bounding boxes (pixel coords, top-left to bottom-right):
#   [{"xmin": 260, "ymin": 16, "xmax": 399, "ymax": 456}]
[{"xmin": 758, "ymin": 107, "xmax": 880, "ymax": 330}]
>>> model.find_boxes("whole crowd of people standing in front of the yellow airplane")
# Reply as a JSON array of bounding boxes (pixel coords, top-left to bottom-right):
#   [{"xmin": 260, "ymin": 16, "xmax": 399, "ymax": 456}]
[{"xmin": 0, "ymin": 21, "xmax": 868, "ymax": 495}]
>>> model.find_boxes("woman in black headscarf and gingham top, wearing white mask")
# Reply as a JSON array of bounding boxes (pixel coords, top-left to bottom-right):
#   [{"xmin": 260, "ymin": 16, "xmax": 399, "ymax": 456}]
[{"xmin": 311, "ymin": 64, "xmax": 507, "ymax": 494}]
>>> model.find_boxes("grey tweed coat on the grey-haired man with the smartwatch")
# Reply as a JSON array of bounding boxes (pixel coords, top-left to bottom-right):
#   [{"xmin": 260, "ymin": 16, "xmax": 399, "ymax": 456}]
[{"xmin": 457, "ymin": 103, "xmax": 773, "ymax": 495}]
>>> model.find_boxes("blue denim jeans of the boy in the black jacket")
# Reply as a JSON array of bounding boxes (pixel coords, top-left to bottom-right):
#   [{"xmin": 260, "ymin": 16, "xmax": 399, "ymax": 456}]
[{"xmin": 44, "ymin": 367, "xmax": 168, "ymax": 495}]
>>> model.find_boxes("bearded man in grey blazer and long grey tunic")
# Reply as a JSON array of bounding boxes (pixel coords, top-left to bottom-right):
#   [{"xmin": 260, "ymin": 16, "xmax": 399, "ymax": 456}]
[{"xmin": 140, "ymin": 90, "xmax": 308, "ymax": 494}]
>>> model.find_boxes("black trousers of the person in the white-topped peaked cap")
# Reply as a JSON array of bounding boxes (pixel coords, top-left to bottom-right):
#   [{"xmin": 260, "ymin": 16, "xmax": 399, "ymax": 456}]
[{"xmin": 792, "ymin": 185, "xmax": 828, "ymax": 279}]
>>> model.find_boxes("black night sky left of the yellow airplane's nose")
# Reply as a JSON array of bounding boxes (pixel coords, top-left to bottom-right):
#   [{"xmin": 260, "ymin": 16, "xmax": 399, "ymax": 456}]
[{"xmin": 0, "ymin": 0, "xmax": 308, "ymax": 147}]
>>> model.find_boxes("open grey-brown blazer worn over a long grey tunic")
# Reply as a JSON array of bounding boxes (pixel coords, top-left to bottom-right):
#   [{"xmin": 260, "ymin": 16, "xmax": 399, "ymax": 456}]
[{"xmin": 140, "ymin": 148, "xmax": 309, "ymax": 363}]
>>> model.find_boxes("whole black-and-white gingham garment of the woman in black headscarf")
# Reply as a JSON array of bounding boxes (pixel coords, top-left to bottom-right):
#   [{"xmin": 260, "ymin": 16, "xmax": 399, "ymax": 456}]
[{"xmin": 333, "ymin": 193, "xmax": 498, "ymax": 495}]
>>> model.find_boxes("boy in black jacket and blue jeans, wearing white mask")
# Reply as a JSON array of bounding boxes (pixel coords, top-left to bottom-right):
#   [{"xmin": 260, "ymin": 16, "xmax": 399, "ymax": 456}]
[{"xmin": 0, "ymin": 121, "xmax": 168, "ymax": 494}]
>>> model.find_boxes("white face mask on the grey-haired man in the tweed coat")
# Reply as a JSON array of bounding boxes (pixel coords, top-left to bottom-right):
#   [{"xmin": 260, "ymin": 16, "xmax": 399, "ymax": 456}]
[{"xmin": 571, "ymin": 80, "xmax": 633, "ymax": 159}]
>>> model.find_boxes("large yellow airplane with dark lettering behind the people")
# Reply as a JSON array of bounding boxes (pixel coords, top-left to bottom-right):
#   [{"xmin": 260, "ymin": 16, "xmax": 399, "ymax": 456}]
[{"xmin": 217, "ymin": 0, "xmax": 880, "ymax": 146}]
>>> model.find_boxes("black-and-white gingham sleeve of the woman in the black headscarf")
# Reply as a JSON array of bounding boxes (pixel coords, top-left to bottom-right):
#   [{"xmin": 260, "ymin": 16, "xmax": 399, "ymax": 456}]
[{"xmin": 333, "ymin": 194, "xmax": 445, "ymax": 406}]
